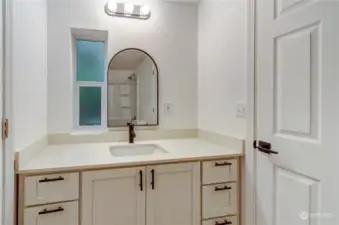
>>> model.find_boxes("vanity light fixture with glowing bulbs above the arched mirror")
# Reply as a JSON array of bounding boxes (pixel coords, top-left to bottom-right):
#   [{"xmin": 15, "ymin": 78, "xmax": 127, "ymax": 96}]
[{"xmin": 105, "ymin": 0, "xmax": 151, "ymax": 20}]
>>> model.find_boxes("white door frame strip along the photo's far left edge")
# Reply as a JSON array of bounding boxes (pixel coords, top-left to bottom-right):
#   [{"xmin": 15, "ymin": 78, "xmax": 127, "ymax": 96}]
[{"xmin": 0, "ymin": 0, "xmax": 15, "ymax": 225}]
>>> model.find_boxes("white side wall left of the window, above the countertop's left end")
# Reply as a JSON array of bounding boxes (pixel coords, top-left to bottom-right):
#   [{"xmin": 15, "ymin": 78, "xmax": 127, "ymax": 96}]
[{"xmin": 12, "ymin": 0, "xmax": 47, "ymax": 150}]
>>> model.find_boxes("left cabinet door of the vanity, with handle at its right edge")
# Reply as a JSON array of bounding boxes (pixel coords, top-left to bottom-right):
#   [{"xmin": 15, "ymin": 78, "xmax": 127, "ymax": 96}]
[{"xmin": 81, "ymin": 167, "xmax": 146, "ymax": 225}]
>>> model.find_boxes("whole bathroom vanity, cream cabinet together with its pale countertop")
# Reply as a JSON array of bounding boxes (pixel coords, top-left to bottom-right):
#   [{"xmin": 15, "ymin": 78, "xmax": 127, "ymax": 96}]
[{"xmin": 17, "ymin": 139, "xmax": 242, "ymax": 225}]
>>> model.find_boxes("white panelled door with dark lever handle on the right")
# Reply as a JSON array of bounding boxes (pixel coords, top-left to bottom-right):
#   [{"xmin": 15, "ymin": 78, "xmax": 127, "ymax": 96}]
[{"xmin": 256, "ymin": 0, "xmax": 339, "ymax": 225}]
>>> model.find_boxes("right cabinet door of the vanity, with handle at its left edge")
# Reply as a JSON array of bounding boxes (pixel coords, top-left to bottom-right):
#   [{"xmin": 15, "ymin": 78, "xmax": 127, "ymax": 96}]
[{"xmin": 146, "ymin": 163, "xmax": 200, "ymax": 225}]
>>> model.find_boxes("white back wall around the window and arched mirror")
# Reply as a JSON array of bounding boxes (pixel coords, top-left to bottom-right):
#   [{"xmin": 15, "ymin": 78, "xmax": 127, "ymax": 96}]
[{"xmin": 47, "ymin": 0, "xmax": 197, "ymax": 133}]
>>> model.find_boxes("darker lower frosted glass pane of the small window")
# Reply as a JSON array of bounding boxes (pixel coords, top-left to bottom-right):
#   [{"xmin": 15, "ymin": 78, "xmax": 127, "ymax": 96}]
[{"xmin": 79, "ymin": 87, "xmax": 101, "ymax": 126}]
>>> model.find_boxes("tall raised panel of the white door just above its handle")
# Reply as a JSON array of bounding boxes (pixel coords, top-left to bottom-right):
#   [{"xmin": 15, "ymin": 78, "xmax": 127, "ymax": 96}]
[{"xmin": 274, "ymin": 24, "xmax": 320, "ymax": 139}]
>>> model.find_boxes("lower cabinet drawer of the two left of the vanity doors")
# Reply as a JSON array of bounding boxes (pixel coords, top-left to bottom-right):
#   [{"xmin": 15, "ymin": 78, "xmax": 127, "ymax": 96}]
[{"xmin": 23, "ymin": 201, "xmax": 79, "ymax": 225}]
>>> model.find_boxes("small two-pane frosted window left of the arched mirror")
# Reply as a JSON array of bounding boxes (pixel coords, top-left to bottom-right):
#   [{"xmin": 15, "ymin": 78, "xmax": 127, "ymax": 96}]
[{"xmin": 75, "ymin": 40, "xmax": 106, "ymax": 127}]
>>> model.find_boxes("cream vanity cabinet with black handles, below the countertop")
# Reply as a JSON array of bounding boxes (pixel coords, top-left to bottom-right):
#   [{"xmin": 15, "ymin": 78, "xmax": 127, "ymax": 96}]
[{"xmin": 15, "ymin": 157, "xmax": 241, "ymax": 225}]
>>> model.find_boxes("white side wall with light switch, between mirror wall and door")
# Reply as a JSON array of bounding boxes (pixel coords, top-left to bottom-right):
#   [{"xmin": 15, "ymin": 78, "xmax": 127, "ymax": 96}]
[{"xmin": 198, "ymin": 0, "xmax": 247, "ymax": 138}]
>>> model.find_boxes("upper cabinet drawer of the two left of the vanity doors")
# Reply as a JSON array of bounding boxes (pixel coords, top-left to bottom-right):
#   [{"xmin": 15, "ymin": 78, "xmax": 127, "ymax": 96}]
[{"xmin": 25, "ymin": 173, "xmax": 79, "ymax": 206}]
